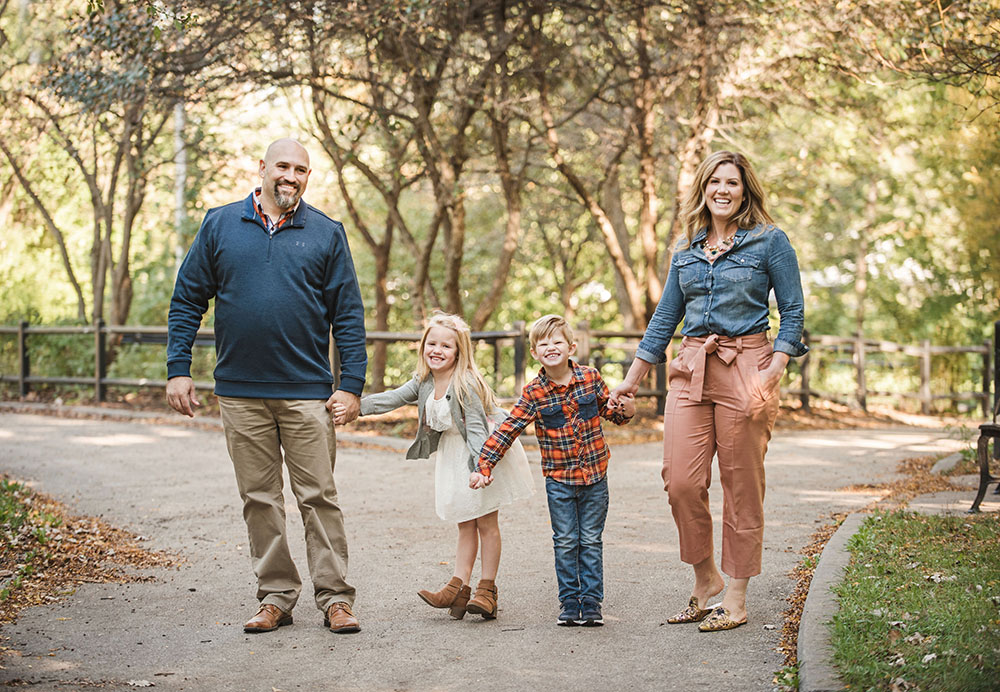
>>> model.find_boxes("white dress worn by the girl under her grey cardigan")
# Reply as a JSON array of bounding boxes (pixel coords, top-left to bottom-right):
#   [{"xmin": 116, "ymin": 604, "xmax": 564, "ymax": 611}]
[{"xmin": 425, "ymin": 396, "xmax": 535, "ymax": 522}]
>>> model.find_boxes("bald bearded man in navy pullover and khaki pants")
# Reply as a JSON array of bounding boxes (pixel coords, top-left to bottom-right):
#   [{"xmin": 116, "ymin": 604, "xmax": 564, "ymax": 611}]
[{"xmin": 167, "ymin": 139, "xmax": 368, "ymax": 633}]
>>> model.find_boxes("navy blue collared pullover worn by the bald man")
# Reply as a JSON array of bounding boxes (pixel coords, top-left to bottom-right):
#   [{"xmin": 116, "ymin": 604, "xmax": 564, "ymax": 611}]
[{"xmin": 167, "ymin": 194, "xmax": 368, "ymax": 399}]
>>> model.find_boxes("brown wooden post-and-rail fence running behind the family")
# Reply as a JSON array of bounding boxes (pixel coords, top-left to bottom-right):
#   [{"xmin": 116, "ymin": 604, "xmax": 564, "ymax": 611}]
[{"xmin": 0, "ymin": 321, "xmax": 1000, "ymax": 416}]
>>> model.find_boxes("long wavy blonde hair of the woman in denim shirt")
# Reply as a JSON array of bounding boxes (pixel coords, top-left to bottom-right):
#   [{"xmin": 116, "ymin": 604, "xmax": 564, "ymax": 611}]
[{"xmin": 680, "ymin": 151, "xmax": 774, "ymax": 247}]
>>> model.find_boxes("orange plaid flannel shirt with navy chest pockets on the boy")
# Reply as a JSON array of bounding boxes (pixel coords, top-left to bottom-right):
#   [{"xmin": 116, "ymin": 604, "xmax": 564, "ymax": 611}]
[{"xmin": 479, "ymin": 360, "xmax": 630, "ymax": 485}]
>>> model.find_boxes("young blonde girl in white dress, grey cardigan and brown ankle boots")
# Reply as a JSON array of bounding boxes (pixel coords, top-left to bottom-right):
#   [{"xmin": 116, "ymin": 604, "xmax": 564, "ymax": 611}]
[{"xmin": 333, "ymin": 314, "xmax": 534, "ymax": 619}]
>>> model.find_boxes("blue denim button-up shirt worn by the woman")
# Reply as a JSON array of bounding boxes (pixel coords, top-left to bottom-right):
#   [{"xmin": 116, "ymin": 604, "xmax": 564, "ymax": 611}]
[{"xmin": 636, "ymin": 224, "xmax": 809, "ymax": 363}]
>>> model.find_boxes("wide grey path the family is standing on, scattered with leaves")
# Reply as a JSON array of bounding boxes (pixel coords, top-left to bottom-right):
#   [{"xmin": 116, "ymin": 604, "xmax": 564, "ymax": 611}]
[{"xmin": 0, "ymin": 413, "xmax": 960, "ymax": 692}]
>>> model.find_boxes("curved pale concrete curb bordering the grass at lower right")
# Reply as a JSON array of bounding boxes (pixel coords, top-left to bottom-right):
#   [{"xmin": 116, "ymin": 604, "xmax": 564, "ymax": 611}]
[{"xmin": 798, "ymin": 514, "xmax": 867, "ymax": 692}]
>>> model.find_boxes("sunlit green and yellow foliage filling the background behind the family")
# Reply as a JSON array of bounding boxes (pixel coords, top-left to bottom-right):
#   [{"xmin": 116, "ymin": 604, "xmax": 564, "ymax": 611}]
[{"xmin": 0, "ymin": 0, "xmax": 1000, "ymax": 406}]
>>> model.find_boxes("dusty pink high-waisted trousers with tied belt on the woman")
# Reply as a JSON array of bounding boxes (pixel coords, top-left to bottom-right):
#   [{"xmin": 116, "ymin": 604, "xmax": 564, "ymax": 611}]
[{"xmin": 663, "ymin": 332, "xmax": 778, "ymax": 579}]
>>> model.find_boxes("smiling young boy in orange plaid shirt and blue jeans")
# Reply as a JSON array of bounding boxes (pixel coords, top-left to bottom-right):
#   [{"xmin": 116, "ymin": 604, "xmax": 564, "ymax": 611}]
[{"xmin": 469, "ymin": 315, "xmax": 635, "ymax": 627}]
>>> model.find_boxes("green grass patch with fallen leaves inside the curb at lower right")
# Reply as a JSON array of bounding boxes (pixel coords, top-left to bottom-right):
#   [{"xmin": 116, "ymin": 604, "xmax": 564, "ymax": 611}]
[{"xmin": 833, "ymin": 512, "xmax": 1000, "ymax": 692}]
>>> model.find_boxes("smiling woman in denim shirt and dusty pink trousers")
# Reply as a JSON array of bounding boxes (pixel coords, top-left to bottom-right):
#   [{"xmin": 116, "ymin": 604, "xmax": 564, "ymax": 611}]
[{"xmin": 611, "ymin": 151, "xmax": 808, "ymax": 632}]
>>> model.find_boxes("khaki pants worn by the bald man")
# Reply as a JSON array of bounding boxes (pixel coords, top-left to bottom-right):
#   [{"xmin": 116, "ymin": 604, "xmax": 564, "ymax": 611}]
[{"xmin": 219, "ymin": 396, "xmax": 354, "ymax": 612}]
